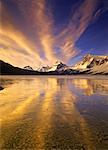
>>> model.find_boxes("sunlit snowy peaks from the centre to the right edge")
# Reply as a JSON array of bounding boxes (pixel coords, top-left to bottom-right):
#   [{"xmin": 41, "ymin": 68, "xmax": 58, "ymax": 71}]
[{"xmin": 37, "ymin": 54, "xmax": 108, "ymax": 74}]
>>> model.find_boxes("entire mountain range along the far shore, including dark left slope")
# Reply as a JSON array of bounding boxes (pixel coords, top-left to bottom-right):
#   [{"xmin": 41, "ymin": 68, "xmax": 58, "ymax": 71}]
[{"xmin": 0, "ymin": 54, "xmax": 108, "ymax": 75}]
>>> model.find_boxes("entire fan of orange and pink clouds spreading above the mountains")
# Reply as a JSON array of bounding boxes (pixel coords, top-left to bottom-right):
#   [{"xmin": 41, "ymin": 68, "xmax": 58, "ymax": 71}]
[{"xmin": 0, "ymin": 0, "xmax": 98, "ymax": 67}]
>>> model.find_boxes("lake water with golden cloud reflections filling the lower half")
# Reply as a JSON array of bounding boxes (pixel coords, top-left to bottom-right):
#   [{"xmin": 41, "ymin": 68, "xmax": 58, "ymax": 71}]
[{"xmin": 0, "ymin": 76, "xmax": 108, "ymax": 150}]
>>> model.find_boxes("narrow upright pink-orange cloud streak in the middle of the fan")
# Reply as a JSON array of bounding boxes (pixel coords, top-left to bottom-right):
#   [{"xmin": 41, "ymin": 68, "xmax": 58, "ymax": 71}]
[{"xmin": 34, "ymin": 0, "xmax": 56, "ymax": 62}]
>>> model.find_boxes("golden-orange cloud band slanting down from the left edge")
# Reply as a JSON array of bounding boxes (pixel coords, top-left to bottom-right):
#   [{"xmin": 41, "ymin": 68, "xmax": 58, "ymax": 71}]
[{"xmin": 0, "ymin": 2, "xmax": 43, "ymax": 65}]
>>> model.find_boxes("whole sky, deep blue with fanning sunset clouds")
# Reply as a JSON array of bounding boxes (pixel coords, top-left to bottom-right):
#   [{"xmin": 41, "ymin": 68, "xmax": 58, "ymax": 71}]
[{"xmin": 0, "ymin": 0, "xmax": 108, "ymax": 68}]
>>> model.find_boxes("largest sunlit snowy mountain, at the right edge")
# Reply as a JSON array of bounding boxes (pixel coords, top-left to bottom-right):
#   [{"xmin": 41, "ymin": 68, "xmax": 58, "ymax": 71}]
[{"xmin": 72, "ymin": 54, "xmax": 108, "ymax": 74}]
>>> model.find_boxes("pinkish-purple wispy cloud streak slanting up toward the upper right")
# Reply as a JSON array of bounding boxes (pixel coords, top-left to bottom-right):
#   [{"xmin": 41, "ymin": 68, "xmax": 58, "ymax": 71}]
[{"xmin": 57, "ymin": 0, "xmax": 97, "ymax": 61}]
